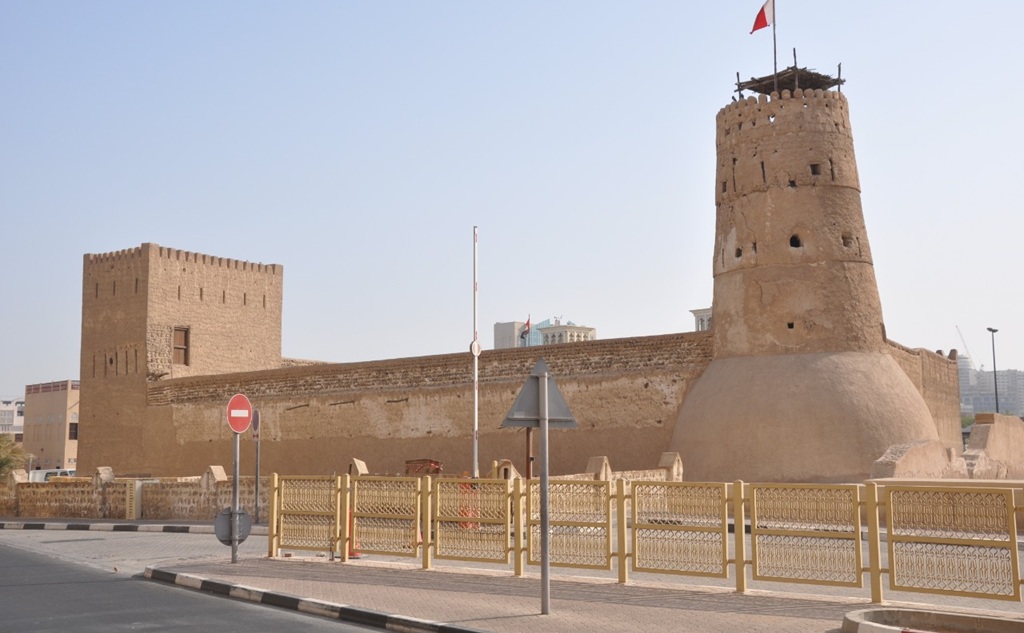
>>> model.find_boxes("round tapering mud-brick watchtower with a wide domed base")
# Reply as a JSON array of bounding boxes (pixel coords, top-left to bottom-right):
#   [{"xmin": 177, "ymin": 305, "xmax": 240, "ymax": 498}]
[{"xmin": 672, "ymin": 90, "xmax": 937, "ymax": 481}]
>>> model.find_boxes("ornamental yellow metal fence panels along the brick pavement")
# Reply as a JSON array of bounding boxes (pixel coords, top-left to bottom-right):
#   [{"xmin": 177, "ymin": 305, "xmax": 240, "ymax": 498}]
[{"xmin": 269, "ymin": 475, "xmax": 1024, "ymax": 602}]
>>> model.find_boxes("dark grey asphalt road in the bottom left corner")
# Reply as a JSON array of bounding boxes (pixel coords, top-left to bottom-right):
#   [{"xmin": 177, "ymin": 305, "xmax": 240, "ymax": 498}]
[{"xmin": 0, "ymin": 537, "xmax": 377, "ymax": 633}]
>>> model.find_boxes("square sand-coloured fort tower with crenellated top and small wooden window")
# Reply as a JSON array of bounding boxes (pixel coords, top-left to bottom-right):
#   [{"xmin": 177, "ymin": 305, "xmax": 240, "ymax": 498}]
[{"xmin": 80, "ymin": 244, "xmax": 284, "ymax": 473}]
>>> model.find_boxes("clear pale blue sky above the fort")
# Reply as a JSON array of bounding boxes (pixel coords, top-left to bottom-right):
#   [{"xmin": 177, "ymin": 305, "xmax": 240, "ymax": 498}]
[{"xmin": 0, "ymin": 0, "xmax": 1024, "ymax": 397}]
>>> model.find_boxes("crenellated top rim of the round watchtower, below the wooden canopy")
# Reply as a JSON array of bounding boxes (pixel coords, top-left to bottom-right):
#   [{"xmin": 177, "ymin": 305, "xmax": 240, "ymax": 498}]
[{"xmin": 716, "ymin": 89, "xmax": 851, "ymax": 142}]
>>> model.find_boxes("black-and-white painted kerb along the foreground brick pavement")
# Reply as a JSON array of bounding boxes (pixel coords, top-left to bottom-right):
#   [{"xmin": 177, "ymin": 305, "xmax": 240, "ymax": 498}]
[{"xmin": 144, "ymin": 566, "xmax": 486, "ymax": 633}]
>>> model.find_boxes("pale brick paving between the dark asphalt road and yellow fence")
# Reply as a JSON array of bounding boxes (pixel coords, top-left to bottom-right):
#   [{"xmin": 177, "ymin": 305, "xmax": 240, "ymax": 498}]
[{"xmin": 0, "ymin": 519, "xmax": 1024, "ymax": 633}]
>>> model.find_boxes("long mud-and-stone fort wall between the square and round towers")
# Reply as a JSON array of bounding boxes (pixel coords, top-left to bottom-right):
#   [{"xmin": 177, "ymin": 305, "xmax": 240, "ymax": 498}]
[{"xmin": 119, "ymin": 332, "xmax": 711, "ymax": 476}]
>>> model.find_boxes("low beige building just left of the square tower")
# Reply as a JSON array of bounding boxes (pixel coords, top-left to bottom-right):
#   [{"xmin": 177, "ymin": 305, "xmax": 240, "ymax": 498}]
[{"xmin": 22, "ymin": 380, "xmax": 79, "ymax": 469}]
